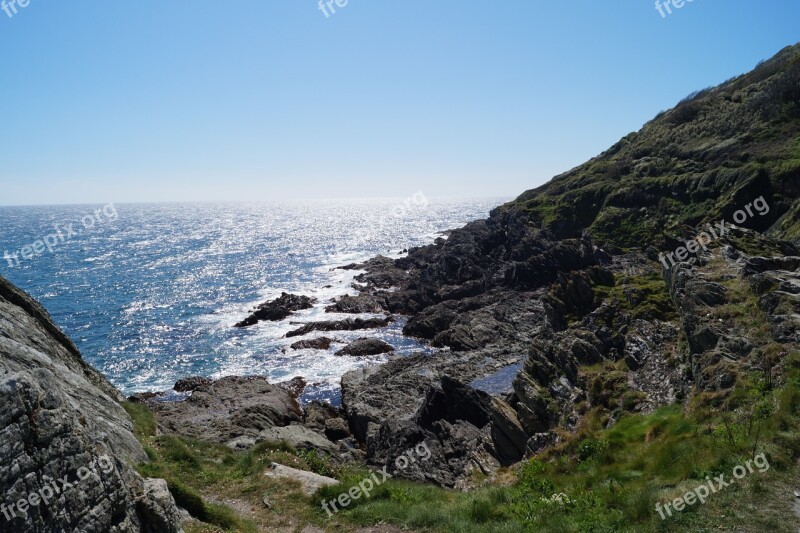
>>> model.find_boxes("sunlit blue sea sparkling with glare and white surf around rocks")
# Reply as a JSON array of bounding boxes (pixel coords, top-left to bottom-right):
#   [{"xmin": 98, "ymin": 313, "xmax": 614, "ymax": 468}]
[{"xmin": 0, "ymin": 200, "xmax": 504, "ymax": 403}]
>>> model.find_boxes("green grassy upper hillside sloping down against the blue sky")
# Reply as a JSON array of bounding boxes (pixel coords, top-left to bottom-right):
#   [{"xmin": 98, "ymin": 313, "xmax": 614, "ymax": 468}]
[{"xmin": 506, "ymin": 45, "xmax": 800, "ymax": 248}]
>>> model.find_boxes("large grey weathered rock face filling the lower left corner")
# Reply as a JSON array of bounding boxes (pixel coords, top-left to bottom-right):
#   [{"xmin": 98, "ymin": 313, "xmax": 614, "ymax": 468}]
[{"xmin": 0, "ymin": 277, "xmax": 181, "ymax": 532}]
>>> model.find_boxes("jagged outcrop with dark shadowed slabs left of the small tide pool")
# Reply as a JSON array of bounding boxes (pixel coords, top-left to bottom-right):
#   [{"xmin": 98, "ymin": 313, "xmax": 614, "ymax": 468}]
[{"xmin": 342, "ymin": 362, "xmax": 527, "ymax": 487}]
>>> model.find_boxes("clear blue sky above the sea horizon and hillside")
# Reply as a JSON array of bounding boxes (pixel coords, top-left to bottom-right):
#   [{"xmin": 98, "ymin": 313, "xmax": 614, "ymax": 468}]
[{"xmin": 0, "ymin": 0, "xmax": 800, "ymax": 205}]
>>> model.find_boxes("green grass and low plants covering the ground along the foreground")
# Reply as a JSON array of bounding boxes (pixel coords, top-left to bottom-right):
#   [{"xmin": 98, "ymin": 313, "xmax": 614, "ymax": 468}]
[{"xmin": 119, "ymin": 353, "xmax": 800, "ymax": 533}]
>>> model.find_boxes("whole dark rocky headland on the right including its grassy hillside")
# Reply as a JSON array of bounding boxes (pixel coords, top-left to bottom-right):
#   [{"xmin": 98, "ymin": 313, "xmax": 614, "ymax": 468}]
[{"xmin": 324, "ymin": 46, "xmax": 800, "ymax": 486}]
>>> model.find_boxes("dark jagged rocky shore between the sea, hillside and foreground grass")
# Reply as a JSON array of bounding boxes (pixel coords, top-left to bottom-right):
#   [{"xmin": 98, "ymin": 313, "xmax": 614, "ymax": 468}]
[{"xmin": 131, "ymin": 209, "xmax": 800, "ymax": 487}]
